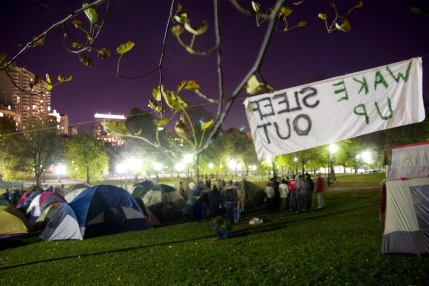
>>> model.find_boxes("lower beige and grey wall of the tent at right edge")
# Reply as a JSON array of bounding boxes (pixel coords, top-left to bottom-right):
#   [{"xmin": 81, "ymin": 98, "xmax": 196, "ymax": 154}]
[{"xmin": 381, "ymin": 177, "xmax": 429, "ymax": 255}]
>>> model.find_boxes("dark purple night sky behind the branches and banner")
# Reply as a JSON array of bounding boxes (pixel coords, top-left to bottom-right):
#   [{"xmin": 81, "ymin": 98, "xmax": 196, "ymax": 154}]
[{"xmin": 0, "ymin": 0, "xmax": 429, "ymax": 131}]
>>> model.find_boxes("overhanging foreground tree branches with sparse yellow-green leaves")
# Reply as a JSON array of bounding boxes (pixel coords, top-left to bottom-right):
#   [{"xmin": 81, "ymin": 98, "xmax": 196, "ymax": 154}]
[{"xmin": 0, "ymin": 0, "xmax": 362, "ymax": 181}]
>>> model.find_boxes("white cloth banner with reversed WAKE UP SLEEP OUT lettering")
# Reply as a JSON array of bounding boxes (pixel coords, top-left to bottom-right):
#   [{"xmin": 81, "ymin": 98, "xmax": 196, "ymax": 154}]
[{"xmin": 244, "ymin": 58, "xmax": 425, "ymax": 159}]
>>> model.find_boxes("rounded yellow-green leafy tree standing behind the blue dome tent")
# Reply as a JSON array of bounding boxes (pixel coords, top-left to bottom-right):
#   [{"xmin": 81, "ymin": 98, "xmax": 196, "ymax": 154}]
[{"xmin": 67, "ymin": 133, "xmax": 109, "ymax": 184}]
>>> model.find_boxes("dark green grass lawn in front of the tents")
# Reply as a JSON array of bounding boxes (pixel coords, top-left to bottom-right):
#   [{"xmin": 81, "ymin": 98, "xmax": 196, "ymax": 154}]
[{"xmin": 0, "ymin": 173, "xmax": 429, "ymax": 285}]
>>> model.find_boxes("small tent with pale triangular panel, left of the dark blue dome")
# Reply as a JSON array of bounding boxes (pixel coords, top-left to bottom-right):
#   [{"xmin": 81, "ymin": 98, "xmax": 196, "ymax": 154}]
[{"xmin": 39, "ymin": 203, "xmax": 83, "ymax": 241}]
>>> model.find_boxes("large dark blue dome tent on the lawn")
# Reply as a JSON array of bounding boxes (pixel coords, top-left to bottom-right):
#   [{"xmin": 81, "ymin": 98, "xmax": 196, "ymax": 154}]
[{"xmin": 69, "ymin": 185, "xmax": 151, "ymax": 238}]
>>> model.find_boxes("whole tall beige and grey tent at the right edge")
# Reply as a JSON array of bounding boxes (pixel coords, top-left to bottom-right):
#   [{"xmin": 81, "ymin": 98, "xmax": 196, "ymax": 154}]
[{"xmin": 380, "ymin": 142, "xmax": 429, "ymax": 255}]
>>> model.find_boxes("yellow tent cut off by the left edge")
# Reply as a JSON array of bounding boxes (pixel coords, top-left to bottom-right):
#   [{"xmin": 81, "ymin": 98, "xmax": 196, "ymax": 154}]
[{"xmin": 0, "ymin": 198, "xmax": 28, "ymax": 238}]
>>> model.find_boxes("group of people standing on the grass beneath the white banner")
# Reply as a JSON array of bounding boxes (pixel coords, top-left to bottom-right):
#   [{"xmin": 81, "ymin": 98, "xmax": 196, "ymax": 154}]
[{"xmin": 265, "ymin": 173, "xmax": 325, "ymax": 213}]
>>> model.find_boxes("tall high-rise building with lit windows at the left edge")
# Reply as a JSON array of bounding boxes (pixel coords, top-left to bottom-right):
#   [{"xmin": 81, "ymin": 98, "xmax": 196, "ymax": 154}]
[{"xmin": 0, "ymin": 66, "xmax": 51, "ymax": 126}]
